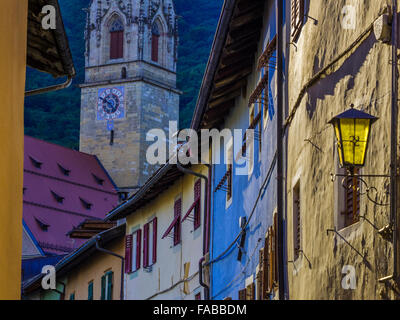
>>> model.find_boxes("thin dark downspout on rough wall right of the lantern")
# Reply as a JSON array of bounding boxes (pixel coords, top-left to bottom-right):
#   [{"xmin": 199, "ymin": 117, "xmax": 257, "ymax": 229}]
[{"xmin": 390, "ymin": 0, "xmax": 400, "ymax": 281}]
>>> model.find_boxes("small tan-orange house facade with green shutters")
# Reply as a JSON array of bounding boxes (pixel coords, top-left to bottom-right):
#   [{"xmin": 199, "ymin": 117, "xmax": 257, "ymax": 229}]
[{"xmin": 65, "ymin": 237, "xmax": 124, "ymax": 300}]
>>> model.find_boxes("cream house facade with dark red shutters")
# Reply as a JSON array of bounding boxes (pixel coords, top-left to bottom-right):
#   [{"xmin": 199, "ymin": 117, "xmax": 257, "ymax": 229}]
[{"xmin": 125, "ymin": 165, "xmax": 208, "ymax": 300}]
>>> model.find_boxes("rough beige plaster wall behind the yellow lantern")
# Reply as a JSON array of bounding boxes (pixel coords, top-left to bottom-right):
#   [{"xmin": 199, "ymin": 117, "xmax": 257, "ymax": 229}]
[{"xmin": 287, "ymin": 0, "xmax": 394, "ymax": 299}]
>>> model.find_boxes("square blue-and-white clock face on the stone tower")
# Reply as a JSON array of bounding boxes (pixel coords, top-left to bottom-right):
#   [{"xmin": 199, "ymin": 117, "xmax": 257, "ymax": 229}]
[{"xmin": 97, "ymin": 87, "xmax": 125, "ymax": 120}]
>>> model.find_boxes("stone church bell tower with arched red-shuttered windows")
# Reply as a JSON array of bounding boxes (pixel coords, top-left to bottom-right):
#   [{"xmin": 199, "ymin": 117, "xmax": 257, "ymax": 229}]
[{"xmin": 80, "ymin": 0, "xmax": 180, "ymax": 192}]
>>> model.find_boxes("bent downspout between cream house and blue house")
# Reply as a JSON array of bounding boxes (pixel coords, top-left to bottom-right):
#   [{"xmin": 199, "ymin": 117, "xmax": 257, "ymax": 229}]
[{"xmin": 176, "ymin": 161, "xmax": 210, "ymax": 300}]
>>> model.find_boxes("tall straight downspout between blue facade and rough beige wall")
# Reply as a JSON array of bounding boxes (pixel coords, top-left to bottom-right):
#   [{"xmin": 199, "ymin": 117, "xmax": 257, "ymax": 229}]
[{"xmin": 276, "ymin": 0, "xmax": 286, "ymax": 300}]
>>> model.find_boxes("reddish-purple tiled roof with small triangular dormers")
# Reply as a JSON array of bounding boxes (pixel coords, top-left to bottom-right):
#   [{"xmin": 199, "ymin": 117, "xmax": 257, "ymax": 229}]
[{"xmin": 21, "ymin": 136, "xmax": 118, "ymax": 254}]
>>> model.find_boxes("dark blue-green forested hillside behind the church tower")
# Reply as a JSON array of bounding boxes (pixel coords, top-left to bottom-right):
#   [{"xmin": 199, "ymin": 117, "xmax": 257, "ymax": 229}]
[{"xmin": 25, "ymin": 0, "xmax": 223, "ymax": 148}]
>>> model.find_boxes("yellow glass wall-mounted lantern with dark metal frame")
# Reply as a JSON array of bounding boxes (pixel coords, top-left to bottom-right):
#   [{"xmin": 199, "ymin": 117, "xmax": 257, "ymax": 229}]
[{"xmin": 329, "ymin": 108, "xmax": 378, "ymax": 169}]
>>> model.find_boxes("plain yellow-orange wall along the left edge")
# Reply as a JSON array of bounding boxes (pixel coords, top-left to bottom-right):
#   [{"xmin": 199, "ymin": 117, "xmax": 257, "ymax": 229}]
[{"xmin": 0, "ymin": 0, "xmax": 28, "ymax": 300}]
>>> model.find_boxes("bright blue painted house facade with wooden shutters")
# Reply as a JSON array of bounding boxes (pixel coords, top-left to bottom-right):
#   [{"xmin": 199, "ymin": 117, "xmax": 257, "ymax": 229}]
[{"xmin": 210, "ymin": 1, "xmax": 284, "ymax": 300}]
